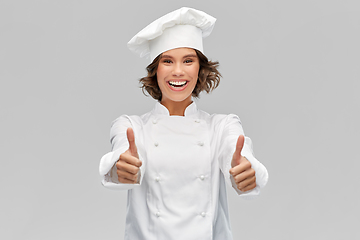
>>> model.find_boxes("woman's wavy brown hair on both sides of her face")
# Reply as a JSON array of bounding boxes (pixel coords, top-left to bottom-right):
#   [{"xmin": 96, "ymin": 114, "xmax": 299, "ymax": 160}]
[{"xmin": 139, "ymin": 49, "xmax": 221, "ymax": 101}]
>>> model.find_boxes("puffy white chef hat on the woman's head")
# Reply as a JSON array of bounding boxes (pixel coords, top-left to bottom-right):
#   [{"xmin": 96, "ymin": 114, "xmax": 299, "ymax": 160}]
[{"xmin": 128, "ymin": 7, "xmax": 216, "ymax": 62}]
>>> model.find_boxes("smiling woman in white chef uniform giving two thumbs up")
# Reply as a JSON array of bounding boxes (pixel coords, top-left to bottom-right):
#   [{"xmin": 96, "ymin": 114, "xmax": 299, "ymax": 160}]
[{"xmin": 100, "ymin": 7, "xmax": 268, "ymax": 240}]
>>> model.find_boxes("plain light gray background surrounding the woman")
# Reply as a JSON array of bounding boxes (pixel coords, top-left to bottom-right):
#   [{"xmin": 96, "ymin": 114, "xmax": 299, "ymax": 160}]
[{"xmin": 0, "ymin": 0, "xmax": 360, "ymax": 240}]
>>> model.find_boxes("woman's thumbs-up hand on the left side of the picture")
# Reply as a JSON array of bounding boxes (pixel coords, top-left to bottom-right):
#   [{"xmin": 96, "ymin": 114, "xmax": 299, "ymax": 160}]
[{"xmin": 116, "ymin": 128, "xmax": 142, "ymax": 183}]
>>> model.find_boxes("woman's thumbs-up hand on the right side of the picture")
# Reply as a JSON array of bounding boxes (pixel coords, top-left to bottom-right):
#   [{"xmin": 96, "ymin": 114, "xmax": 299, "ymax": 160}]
[{"xmin": 229, "ymin": 135, "xmax": 256, "ymax": 192}]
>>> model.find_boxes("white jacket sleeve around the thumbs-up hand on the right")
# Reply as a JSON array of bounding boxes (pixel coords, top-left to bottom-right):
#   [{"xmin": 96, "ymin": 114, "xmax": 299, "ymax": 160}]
[{"xmin": 219, "ymin": 114, "xmax": 268, "ymax": 199}]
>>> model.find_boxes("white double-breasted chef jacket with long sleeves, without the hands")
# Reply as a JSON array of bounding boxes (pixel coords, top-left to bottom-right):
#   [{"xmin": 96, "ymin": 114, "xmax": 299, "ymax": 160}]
[{"xmin": 100, "ymin": 102, "xmax": 268, "ymax": 240}]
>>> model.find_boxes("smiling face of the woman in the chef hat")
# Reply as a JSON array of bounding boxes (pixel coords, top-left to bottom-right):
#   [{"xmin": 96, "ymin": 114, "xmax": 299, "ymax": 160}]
[{"xmin": 157, "ymin": 48, "xmax": 200, "ymax": 103}]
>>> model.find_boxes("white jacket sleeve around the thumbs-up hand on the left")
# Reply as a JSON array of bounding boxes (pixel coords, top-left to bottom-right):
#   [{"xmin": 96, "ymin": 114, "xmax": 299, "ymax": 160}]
[{"xmin": 99, "ymin": 115, "xmax": 145, "ymax": 190}]
